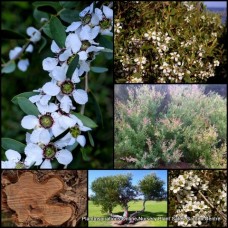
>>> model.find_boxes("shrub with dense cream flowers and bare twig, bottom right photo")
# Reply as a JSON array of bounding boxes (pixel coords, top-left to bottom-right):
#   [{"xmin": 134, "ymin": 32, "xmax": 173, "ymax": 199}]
[{"xmin": 169, "ymin": 170, "xmax": 227, "ymax": 227}]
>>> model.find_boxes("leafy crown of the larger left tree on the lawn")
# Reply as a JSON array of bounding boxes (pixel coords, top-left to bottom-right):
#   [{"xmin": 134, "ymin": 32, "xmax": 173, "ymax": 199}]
[{"xmin": 91, "ymin": 174, "xmax": 137, "ymax": 214}]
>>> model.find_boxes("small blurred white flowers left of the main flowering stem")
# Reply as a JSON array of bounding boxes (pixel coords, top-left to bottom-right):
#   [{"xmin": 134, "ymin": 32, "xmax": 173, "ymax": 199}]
[{"xmin": 9, "ymin": 27, "xmax": 41, "ymax": 72}]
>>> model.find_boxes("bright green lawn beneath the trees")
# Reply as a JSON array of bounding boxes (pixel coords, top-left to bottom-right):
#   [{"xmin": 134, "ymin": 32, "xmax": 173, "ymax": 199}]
[{"xmin": 88, "ymin": 201, "xmax": 167, "ymax": 227}]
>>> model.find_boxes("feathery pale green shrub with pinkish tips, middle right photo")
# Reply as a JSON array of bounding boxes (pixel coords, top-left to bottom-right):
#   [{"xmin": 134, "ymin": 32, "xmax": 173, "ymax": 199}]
[{"xmin": 115, "ymin": 85, "xmax": 227, "ymax": 168}]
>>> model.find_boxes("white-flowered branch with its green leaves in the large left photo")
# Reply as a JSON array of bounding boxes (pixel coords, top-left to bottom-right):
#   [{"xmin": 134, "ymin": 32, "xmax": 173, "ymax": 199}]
[{"xmin": 2, "ymin": 1, "xmax": 113, "ymax": 169}]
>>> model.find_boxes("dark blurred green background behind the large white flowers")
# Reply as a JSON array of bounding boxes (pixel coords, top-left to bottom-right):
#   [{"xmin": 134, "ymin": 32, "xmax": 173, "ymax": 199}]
[{"xmin": 1, "ymin": 1, "xmax": 113, "ymax": 168}]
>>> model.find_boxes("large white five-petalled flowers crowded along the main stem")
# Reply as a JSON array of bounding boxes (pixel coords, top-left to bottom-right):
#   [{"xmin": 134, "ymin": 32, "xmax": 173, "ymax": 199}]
[{"xmin": 2, "ymin": 3, "xmax": 113, "ymax": 169}]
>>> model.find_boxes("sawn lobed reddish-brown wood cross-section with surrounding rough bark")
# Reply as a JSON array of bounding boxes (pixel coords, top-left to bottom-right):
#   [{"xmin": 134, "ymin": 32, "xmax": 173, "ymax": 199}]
[{"xmin": 2, "ymin": 170, "xmax": 87, "ymax": 227}]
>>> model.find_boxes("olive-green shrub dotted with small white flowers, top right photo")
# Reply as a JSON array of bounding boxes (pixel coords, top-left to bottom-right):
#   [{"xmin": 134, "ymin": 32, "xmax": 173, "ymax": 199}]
[{"xmin": 114, "ymin": 1, "xmax": 226, "ymax": 83}]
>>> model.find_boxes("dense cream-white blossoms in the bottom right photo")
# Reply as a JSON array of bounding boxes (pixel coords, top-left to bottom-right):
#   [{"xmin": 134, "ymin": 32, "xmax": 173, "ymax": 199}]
[{"xmin": 170, "ymin": 171, "xmax": 227, "ymax": 227}]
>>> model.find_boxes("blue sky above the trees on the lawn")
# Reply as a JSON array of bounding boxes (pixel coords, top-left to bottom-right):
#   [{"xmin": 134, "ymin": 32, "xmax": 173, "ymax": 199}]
[{"xmin": 89, "ymin": 170, "xmax": 167, "ymax": 196}]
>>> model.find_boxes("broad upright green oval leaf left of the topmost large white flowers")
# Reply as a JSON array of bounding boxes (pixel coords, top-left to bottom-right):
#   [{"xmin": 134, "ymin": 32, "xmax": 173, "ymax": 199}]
[{"xmin": 50, "ymin": 17, "xmax": 66, "ymax": 48}]
